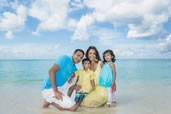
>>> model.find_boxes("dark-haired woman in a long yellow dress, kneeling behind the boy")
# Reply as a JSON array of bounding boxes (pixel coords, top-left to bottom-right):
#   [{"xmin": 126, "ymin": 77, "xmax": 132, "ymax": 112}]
[{"xmin": 81, "ymin": 46, "xmax": 107, "ymax": 107}]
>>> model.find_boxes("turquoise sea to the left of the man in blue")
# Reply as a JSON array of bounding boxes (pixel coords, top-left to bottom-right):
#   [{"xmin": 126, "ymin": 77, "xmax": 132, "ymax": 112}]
[{"xmin": 0, "ymin": 60, "xmax": 55, "ymax": 84}]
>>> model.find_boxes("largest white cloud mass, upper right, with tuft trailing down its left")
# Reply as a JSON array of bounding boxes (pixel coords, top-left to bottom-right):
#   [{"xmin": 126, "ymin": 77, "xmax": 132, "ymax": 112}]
[{"xmin": 73, "ymin": 0, "xmax": 171, "ymax": 40}]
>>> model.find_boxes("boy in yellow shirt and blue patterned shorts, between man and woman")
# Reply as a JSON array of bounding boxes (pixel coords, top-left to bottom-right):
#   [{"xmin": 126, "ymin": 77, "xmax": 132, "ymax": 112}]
[{"xmin": 68, "ymin": 58, "xmax": 95, "ymax": 102}]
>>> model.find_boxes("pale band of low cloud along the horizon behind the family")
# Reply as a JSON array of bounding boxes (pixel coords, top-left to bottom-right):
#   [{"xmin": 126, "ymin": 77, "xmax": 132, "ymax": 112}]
[{"xmin": 0, "ymin": 41, "xmax": 171, "ymax": 59}]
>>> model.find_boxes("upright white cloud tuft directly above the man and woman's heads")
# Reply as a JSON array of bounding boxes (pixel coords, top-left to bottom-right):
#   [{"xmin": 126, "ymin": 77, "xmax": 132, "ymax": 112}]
[{"xmin": 72, "ymin": 15, "xmax": 95, "ymax": 41}]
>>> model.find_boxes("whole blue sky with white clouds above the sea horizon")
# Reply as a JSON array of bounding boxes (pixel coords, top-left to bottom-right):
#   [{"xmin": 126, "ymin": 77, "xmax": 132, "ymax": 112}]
[{"xmin": 0, "ymin": 0, "xmax": 171, "ymax": 59}]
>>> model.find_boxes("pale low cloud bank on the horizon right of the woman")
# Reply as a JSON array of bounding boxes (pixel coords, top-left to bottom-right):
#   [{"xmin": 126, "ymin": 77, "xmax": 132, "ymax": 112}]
[{"xmin": 100, "ymin": 40, "xmax": 165, "ymax": 59}]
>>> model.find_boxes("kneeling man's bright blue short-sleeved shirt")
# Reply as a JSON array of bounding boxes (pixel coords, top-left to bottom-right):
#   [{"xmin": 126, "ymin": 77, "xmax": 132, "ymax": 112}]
[{"xmin": 40, "ymin": 55, "xmax": 77, "ymax": 90}]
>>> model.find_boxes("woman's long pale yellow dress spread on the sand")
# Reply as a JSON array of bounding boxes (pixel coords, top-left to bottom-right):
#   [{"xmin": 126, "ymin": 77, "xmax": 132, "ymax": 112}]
[{"xmin": 81, "ymin": 61, "xmax": 107, "ymax": 107}]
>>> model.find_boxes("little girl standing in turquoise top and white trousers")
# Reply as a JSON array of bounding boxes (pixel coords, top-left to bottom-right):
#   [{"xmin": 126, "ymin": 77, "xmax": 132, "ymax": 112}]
[{"xmin": 99, "ymin": 50, "xmax": 116, "ymax": 107}]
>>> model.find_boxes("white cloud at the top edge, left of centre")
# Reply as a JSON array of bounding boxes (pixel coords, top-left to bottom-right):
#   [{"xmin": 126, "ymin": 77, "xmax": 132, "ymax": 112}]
[{"xmin": 29, "ymin": 0, "xmax": 69, "ymax": 34}]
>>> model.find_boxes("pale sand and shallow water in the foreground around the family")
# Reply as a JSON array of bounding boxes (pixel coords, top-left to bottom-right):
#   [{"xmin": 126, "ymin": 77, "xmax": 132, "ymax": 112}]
[{"xmin": 0, "ymin": 81, "xmax": 171, "ymax": 114}]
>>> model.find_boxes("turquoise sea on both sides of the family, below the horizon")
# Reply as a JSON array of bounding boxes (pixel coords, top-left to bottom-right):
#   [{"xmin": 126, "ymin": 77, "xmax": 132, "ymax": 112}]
[{"xmin": 0, "ymin": 59, "xmax": 171, "ymax": 84}]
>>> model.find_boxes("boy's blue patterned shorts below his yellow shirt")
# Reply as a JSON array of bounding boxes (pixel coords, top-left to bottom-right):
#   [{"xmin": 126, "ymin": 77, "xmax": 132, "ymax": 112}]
[{"xmin": 75, "ymin": 91, "xmax": 88, "ymax": 102}]
